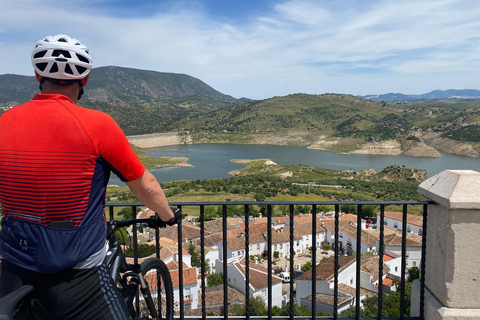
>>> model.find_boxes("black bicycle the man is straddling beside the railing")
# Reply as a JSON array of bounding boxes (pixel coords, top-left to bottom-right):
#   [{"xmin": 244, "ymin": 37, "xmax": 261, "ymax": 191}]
[{"xmin": 0, "ymin": 208, "xmax": 182, "ymax": 320}]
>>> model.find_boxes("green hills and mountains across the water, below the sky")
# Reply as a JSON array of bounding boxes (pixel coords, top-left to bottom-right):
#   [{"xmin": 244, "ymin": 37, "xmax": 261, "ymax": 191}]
[{"xmin": 0, "ymin": 66, "xmax": 480, "ymax": 157}]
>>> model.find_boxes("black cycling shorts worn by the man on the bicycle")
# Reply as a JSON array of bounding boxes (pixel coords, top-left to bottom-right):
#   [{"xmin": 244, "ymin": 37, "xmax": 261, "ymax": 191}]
[{"xmin": 0, "ymin": 260, "xmax": 130, "ymax": 320}]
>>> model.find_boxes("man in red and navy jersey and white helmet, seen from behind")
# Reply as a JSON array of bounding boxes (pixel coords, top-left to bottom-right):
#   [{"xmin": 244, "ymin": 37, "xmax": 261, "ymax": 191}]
[{"xmin": 0, "ymin": 35, "xmax": 174, "ymax": 319}]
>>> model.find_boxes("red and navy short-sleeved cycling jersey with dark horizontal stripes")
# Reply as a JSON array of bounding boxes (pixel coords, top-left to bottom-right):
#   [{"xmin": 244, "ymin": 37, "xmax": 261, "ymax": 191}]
[{"xmin": 0, "ymin": 94, "xmax": 145, "ymax": 273}]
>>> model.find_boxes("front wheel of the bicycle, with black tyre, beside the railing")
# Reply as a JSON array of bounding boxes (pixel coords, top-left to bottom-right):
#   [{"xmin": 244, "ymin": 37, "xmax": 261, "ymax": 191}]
[{"xmin": 133, "ymin": 258, "xmax": 174, "ymax": 320}]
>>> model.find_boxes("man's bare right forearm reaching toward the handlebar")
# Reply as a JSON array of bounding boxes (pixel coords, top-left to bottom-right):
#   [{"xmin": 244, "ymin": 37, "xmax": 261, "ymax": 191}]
[{"xmin": 125, "ymin": 170, "xmax": 173, "ymax": 221}]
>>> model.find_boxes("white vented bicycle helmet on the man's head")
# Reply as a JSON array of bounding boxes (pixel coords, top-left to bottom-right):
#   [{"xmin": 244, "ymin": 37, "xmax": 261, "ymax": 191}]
[{"xmin": 32, "ymin": 34, "xmax": 92, "ymax": 80}]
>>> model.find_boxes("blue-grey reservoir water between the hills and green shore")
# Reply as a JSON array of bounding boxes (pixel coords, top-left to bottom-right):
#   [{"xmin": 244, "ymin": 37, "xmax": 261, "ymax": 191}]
[{"xmin": 110, "ymin": 143, "xmax": 480, "ymax": 185}]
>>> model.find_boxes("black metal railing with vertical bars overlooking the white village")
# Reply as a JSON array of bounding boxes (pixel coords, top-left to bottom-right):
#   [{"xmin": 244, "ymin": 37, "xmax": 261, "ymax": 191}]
[{"xmin": 107, "ymin": 201, "xmax": 433, "ymax": 320}]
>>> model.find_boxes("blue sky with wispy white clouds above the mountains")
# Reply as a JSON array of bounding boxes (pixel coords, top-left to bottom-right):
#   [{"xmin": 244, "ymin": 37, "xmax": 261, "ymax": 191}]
[{"xmin": 0, "ymin": 0, "xmax": 480, "ymax": 99}]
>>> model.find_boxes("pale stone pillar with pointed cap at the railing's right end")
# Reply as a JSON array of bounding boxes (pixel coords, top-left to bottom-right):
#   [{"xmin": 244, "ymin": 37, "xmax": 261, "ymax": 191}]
[{"xmin": 412, "ymin": 170, "xmax": 480, "ymax": 320}]
